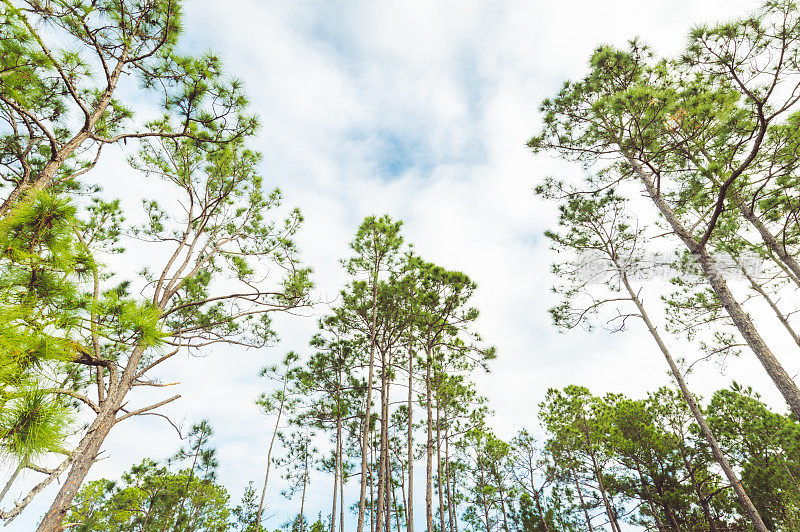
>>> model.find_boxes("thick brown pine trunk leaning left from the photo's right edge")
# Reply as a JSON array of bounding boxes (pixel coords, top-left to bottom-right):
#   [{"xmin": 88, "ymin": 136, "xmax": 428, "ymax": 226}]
[{"xmin": 628, "ymin": 158, "xmax": 800, "ymax": 420}]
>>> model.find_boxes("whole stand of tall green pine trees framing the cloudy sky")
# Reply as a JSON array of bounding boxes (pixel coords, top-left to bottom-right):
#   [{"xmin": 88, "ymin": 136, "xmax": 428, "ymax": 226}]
[{"xmin": 0, "ymin": 0, "xmax": 800, "ymax": 532}]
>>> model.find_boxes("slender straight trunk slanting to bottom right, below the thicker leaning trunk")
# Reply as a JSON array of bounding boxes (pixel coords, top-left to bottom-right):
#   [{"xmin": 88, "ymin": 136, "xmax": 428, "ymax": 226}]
[{"xmin": 615, "ymin": 258, "xmax": 767, "ymax": 532}]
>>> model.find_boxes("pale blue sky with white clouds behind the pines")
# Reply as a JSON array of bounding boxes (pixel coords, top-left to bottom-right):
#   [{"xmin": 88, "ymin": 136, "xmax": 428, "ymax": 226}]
[{"xmin": 7, "ymin": 0, "xmax": 800, "ymax": 532}]
